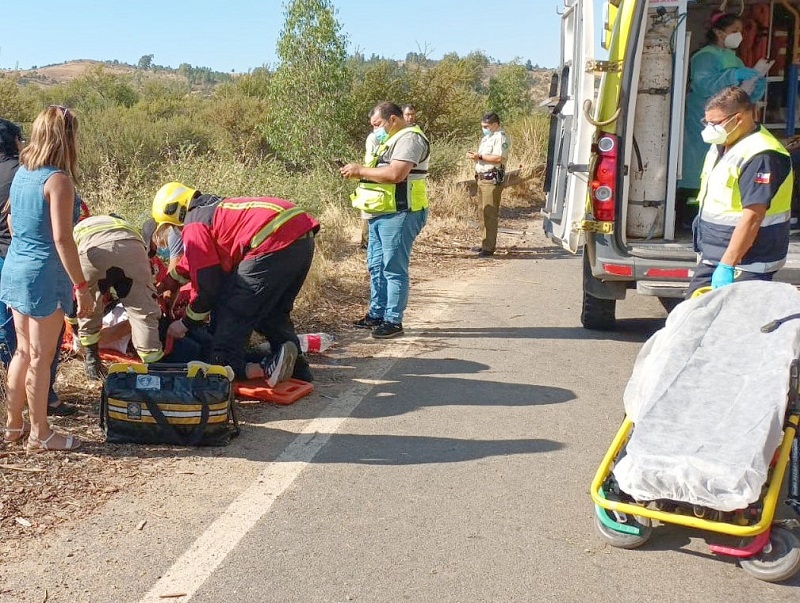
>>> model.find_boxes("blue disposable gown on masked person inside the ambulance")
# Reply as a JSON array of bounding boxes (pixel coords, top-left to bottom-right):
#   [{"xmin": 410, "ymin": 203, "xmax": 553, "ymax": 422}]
[{"xmin": 678, "ymin": 44, "xmax": 765, "ymax": 189}]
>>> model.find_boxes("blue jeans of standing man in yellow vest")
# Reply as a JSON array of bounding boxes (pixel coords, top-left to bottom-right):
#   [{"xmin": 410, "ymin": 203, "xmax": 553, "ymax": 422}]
[{"xmin": 367, "ymin": 208, "xmax": 428, "ymax": 324}]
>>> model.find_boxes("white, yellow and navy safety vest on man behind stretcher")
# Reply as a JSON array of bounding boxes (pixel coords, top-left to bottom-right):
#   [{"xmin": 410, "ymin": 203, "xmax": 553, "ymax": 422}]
[{"xmin": 696, "ymin": 126, "xmax": 794, "ymax": 273}]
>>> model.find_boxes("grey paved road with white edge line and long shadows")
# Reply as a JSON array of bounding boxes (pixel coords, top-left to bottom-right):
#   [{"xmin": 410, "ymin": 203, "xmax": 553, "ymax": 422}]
[{"xmin": 0, "ymin": 229, "xmax": 800, "ymax": 603}]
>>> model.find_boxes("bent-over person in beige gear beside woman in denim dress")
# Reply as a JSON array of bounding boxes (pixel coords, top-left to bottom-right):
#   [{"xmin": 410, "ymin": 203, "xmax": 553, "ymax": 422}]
[{"xmin": 73, "ymin": 216, "xmax": 164, "ymax": 379}]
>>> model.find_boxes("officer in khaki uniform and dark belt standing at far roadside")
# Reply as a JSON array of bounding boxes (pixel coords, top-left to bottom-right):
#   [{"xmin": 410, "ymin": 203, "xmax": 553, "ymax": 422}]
[{"xmin": 467, "ymin": 112, "xmax": 511, "ymax": 257}]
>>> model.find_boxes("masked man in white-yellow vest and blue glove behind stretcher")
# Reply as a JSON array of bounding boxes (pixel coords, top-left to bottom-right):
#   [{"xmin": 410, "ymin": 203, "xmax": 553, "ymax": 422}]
[{"xmin": 687, "ymin": 86, "xmax": 793, "ymax": 295}]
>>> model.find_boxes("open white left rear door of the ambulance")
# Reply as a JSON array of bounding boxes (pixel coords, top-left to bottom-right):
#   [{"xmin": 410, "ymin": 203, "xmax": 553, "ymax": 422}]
[{"xmin": 543, "ymin": 0, "xmax": 595, "ymax": 253}]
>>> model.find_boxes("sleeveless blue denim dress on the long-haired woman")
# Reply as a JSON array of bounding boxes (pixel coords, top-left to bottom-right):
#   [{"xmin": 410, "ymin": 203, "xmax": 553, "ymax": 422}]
[{"xmin": 0, "ymin": 166, "xmax": 73, "ymax": 318}]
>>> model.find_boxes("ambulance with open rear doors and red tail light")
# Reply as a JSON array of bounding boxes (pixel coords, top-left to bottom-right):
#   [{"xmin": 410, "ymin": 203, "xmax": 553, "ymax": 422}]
[{"xmin": 543, "ymin": 0, "xmax": 800, "ymax": 330}]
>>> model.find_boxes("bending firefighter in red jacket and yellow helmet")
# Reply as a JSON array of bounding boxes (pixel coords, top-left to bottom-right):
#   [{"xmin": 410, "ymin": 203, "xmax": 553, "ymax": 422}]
[{"xmin": 152, "ymin": 182, "xmax": 319, "ymax": 387}]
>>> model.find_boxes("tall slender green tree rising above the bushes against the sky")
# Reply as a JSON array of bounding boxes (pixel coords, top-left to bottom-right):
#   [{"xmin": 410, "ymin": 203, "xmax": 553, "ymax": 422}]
[{"xmin": 265, "ymin": 0, "xmax": 350, "ymax": 164}]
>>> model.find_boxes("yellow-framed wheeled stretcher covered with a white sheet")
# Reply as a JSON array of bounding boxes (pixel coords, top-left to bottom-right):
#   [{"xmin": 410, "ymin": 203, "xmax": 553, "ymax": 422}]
[{"xmin": 591, "ymin": 282, "xmax": 800, "ymax": 582}]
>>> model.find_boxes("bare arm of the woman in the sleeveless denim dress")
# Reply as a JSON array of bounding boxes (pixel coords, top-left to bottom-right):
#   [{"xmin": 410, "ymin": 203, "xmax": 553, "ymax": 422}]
[{"xmin": 44, "ymin": 172, "xmax": 94, "ymax": 318}]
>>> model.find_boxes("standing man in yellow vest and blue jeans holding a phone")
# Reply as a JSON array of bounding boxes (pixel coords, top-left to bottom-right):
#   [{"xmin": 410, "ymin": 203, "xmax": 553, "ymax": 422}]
[{"xmin": 341, "ymin": 102, "xmax": 430, "ymax": 339}]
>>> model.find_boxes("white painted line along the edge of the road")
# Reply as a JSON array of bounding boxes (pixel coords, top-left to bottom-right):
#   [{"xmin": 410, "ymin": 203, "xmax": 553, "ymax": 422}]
[{"xmin": 139, "ymin": 354, "xmax": 406, "ymax": 603}]
